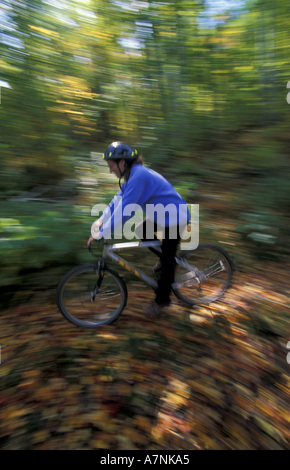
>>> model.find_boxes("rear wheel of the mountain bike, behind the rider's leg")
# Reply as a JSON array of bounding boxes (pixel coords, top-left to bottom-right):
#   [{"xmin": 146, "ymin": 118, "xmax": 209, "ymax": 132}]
[{"xmin": 172, "ymin": 244, "xmax": 234, "ymax": 305}]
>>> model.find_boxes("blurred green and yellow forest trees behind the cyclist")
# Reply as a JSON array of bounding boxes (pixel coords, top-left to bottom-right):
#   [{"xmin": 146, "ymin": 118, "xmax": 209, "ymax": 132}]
[{"xmin": 0, "ymin": 0, "xmax": 290, "ymax": 298}]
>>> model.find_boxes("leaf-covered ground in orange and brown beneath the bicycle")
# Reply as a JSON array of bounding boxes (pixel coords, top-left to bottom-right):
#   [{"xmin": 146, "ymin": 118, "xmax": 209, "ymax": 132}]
[{"xmin": 0, "ymin": 263, "xmax": 290, "ymax": 450}]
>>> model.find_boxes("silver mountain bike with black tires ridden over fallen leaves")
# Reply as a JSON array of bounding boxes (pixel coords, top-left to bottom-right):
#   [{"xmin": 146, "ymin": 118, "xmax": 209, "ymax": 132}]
[{"xmin": 57, "ymin": 240, "xmax": 234, "ymax": 328}]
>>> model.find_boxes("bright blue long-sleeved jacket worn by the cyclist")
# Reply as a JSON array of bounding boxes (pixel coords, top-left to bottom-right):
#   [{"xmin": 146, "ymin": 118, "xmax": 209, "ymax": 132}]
[{"xmin": 100, "ymin": 164, "xmax": 190, "ymax": 238}]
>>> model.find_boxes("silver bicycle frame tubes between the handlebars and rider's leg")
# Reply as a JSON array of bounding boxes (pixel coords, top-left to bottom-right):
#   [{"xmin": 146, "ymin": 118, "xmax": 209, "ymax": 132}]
[{"xmin": 103, "ymin": 240, "xmax": 161, "ymax": 289}]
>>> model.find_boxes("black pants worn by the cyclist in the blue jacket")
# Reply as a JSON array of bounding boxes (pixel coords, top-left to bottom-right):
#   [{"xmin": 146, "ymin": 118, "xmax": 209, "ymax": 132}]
[{"xmin": 135, "ymin": 219, "xmax": 180, "ymax": 304}]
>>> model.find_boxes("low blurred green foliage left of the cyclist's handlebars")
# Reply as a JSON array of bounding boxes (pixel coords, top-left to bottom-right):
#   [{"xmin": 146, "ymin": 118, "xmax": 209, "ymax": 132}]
[{"xmin": 0, "ymin": 202, "xmax": 91, "ymax": 290}]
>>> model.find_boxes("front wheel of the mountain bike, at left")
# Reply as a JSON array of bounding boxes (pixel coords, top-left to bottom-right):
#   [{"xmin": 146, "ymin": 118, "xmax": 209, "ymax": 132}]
[{"xmin": 57, "ymin": 264, "xmax": 127, "ymax": 328}]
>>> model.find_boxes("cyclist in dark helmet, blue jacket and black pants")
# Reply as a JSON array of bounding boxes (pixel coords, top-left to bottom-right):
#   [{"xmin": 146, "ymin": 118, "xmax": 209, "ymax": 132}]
[{"xmin": 89, "ymin": 142, "xmax": 190, "ymax": 316}]
